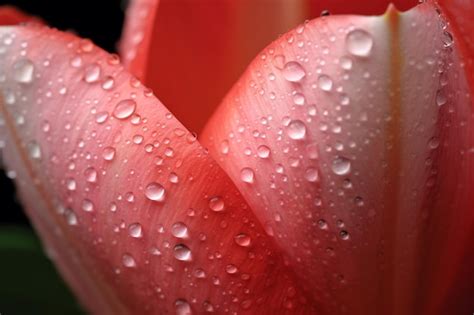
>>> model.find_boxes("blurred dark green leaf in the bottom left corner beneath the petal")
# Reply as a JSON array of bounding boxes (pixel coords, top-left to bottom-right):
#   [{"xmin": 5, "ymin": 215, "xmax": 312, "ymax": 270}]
[{"xmin": 0, "ymin": 226, "xmax": 84, "ymax": 315}]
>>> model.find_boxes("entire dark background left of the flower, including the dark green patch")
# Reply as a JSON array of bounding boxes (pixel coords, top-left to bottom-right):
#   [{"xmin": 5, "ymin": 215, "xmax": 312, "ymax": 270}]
[{"xmin": 0, "ymin": 0, "xmax": 127, "ymax": 315}]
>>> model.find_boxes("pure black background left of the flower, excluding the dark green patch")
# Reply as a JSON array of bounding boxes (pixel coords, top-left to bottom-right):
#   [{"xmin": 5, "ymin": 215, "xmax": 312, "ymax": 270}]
[{"xmin": 0, "ymin": 0, "xmax": 123, "ymax": 226}]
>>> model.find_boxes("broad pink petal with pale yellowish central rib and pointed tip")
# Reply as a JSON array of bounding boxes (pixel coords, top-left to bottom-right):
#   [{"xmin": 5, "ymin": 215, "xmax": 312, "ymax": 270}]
[{"xmin": 202, "ymin": 4, "xmax": 474, "ymax": 314}]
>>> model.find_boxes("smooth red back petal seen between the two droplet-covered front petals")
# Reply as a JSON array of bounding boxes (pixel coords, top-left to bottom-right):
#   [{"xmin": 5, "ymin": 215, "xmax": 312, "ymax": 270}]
[{"xmin": 122, "ymin": 0, "xmax": 309, "ymax": 132}]
